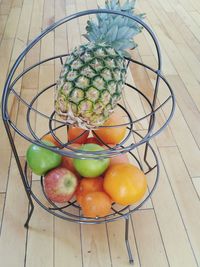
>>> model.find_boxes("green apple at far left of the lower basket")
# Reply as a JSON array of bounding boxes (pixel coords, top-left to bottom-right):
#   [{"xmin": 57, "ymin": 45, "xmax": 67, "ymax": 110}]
[{"xmin": 26, "ymin": 141, "xmax": 62, "ymax": 175}]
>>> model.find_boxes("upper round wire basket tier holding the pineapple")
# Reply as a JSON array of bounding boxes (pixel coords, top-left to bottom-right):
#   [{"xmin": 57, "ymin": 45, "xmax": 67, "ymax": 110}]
[{"xmin": 2, "ymin": 46, "xmax": 175, "ymax": 158}]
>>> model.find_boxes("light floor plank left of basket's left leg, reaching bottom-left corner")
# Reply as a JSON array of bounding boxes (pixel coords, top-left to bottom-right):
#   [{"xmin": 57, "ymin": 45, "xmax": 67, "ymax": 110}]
[{"xmin": 0, "ymin": 158, "xmax": 28, "ymax": 267}]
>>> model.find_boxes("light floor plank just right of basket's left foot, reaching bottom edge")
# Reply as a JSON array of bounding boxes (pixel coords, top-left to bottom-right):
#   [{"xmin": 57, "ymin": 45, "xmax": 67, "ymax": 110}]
[{"xmin": 26, "ymin": 181, "xmax": 54, "ymax": 267}]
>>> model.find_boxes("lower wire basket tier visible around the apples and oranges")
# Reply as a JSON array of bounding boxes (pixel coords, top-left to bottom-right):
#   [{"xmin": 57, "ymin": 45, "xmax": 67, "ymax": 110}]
[{"xmin": 24, "ymin": 144, "xmax": 159, "ymax": 224}]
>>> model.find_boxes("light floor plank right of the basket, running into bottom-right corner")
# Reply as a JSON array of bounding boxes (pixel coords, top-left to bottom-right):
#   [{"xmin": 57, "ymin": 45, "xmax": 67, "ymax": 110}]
[{"xmin": 160, "ymin": 147, "xmax": 200, "ymax": 264}]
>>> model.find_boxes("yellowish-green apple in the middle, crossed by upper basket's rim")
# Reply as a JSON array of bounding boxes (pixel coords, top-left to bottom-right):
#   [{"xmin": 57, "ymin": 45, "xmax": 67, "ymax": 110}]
[{"xmin": 74, "ymin": 144, "xmax": 110, "ymax": 177}]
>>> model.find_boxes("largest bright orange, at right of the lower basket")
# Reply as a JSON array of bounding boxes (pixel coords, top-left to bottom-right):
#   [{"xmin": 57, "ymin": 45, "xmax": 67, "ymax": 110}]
[{"xmin": 103, "ymin": 163, "xmax": 147, "ymax": 205}]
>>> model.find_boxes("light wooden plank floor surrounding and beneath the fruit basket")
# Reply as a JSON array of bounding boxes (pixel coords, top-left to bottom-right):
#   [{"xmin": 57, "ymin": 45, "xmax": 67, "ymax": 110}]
[{"xmin": 0, "ymin": 0, "xmax": 200, "ymax": 267}]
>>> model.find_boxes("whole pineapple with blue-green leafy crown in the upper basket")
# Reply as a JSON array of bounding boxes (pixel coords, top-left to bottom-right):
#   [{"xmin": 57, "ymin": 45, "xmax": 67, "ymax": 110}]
[{"xmin": 55, "ymin": 0, "xmax": 143, "ymax": 129}]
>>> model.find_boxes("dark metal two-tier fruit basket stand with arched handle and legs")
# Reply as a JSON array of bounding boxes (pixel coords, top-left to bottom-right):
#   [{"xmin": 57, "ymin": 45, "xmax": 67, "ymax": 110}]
[{"xmin": 2, "ymin": 9, "xmax": 175, "ymax": 263}]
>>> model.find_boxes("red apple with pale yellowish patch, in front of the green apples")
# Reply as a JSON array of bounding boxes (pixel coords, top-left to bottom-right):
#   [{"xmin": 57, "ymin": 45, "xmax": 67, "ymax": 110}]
[{"xmin": 44, "ymin": 167, "xmax": 78, "ymax": 203}]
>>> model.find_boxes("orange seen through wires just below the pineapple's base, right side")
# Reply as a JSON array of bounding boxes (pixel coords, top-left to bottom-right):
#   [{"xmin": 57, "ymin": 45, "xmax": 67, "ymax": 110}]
[{"xmin": 94, "ymin": 112, "xmax": 126, "ymax": 144}]
